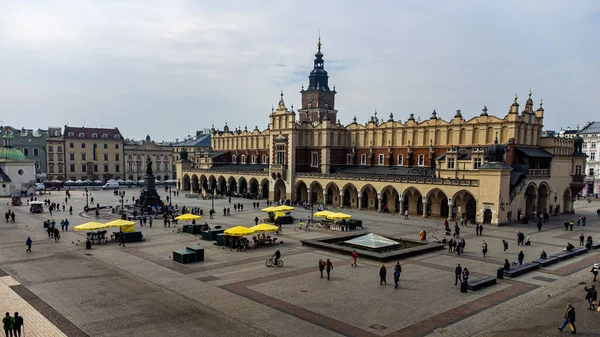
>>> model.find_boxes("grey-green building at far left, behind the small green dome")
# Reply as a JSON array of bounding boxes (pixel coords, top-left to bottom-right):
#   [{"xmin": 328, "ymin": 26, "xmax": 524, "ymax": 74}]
[{"xmin": 0, "ymin": 125, "xmax": 48, "ymax": 182}]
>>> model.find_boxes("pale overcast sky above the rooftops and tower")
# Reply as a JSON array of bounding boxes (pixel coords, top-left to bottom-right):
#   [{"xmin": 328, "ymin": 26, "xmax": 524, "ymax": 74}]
[{"xmin": 0, "ymin": 0, "xmax": 600, "ymax": 140}]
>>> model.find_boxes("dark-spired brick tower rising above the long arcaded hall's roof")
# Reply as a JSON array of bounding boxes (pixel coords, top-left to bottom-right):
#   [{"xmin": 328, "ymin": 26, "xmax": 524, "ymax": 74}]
[{"xmin": 298, "ymin": 37, "xmax": 337, "ymax": 123}]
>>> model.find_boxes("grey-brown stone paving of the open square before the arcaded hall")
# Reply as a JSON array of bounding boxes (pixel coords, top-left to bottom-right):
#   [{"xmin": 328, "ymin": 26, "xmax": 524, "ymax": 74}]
[{"xmin": 0, "ymin": 189, "xmax": 600, "ymax": 337}]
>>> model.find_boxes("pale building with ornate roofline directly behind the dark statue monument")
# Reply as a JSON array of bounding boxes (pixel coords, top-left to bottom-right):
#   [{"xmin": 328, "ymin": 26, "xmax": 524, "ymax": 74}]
[{"xmin": 125, "ymin": 135, "xmax": 179, "ymax": 182}]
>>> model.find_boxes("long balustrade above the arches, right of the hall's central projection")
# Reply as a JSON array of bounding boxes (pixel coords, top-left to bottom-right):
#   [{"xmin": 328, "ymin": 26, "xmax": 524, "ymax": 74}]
[{"xmin": 296, "ymin": 172, "xmax": 479, "ymax": 187}]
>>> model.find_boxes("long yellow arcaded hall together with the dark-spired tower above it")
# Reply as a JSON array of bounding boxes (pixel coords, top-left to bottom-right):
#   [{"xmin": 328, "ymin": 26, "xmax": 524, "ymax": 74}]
[{"xmin": 177, "ymin": 41, "xmax": 585, "ymax": 224}]
